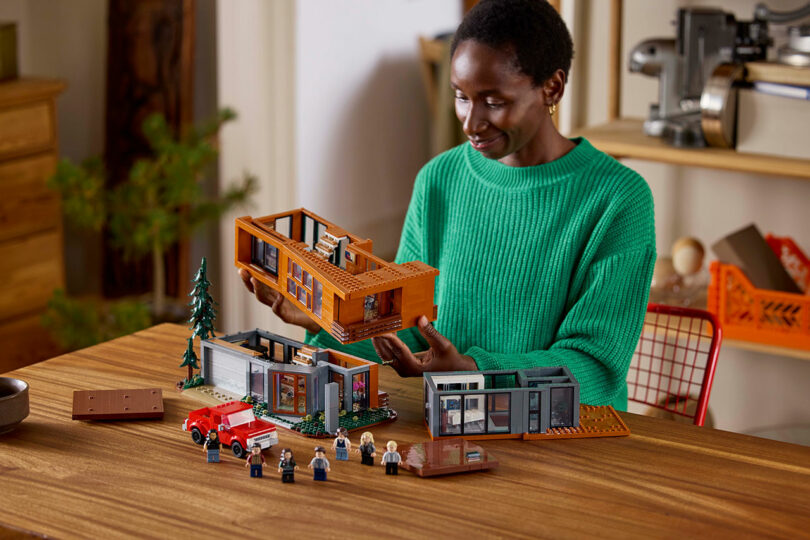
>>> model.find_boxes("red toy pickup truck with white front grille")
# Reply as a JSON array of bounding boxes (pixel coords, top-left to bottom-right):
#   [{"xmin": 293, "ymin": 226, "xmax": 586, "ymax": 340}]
[{"xmin": 183, "ymin": 401, "xmax": 278, "ymax": 458}]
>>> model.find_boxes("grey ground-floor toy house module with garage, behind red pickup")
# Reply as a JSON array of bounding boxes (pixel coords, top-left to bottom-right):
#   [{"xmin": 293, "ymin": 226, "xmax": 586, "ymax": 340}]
[{"xmin": 200, "ymin": 329, "xmax": 396, "ymax": 436}]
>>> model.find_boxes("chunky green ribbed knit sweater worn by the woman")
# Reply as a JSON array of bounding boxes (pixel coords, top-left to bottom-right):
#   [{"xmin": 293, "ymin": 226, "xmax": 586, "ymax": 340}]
[{"xmin": 307, "ymin": 139, "xmax": 656, "ymax": 410}]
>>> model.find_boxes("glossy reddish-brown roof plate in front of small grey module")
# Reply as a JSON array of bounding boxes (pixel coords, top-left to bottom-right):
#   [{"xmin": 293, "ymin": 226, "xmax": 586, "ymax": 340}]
[{"xmin": 398, "ymin": 437, "xmax": 498, "ymax": 477}]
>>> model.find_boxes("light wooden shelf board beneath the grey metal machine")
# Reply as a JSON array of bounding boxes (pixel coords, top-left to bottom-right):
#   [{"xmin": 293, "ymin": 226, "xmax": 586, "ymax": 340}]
[{"xmin": 573, "ymin": 118, "xmax": 810, "ymax": 180}]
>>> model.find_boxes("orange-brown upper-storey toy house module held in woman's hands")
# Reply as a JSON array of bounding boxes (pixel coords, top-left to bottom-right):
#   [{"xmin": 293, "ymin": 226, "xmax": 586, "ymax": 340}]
[{"xmin": 235, "ymin": 208, "xmax": 439, "ymax": 343}]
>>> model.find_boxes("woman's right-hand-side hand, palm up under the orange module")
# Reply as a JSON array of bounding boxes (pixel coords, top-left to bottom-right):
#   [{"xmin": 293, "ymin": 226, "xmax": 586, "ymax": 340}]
[{"xmin": 371, "ymin": 315, "xmax": 478, "ymax": 377}]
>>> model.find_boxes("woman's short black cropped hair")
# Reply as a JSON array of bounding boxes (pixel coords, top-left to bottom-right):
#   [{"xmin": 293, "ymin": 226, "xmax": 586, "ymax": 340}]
[{"xmin": 450, "ymin": 0, "xmax": 574, "ymax": 86}]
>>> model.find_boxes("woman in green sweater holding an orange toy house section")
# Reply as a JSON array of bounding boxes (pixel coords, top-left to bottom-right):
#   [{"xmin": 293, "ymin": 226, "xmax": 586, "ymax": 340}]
[{"xmin": 238, "ymin": 0, "xmax": 655, "ymax": 409}]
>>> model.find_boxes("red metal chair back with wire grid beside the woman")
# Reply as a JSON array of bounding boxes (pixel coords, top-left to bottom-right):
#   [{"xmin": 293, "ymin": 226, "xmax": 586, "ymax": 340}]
[{"xmin": 627, "ymin": 304, "xmax": 723, "ymax": 426}]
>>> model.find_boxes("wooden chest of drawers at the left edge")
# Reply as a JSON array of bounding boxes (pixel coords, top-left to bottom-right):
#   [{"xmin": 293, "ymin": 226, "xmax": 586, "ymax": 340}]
[{"xmin": 0, "ymin": 79, "xmax": 65, "ymax": 373}]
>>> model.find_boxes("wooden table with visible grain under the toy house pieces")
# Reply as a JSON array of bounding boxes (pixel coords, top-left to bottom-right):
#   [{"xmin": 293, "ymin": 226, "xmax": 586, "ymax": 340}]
[{"xmin": 0, "ymin": 325, "xmax": 810, "ymax": 538}]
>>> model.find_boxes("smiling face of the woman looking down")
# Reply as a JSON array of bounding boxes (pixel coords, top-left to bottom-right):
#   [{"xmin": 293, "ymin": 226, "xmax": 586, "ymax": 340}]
[{"xmin": 450, "ymin": 39, "xmax": 551, "ymax": 166}]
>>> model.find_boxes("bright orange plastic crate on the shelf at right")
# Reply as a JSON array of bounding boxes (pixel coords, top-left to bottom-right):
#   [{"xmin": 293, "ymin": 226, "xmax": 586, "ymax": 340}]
[{"xmin": 708, "ymin": 252, "xmax": 810, "ymax": 350}]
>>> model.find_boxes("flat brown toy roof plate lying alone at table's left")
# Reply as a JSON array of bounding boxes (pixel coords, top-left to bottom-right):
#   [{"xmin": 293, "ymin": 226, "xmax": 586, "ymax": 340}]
[{"xmin": 73, "ymin": 388, "xmax": 163, "ymax": 420}]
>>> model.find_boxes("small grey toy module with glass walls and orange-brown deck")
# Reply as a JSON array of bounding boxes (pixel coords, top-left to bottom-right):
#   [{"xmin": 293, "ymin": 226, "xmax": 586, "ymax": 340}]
[{"xmin": 423, "ymin": 366, "xmax": 630, "ymax": 439}]
